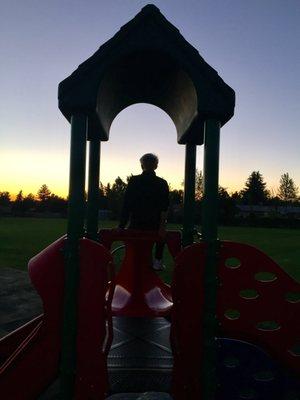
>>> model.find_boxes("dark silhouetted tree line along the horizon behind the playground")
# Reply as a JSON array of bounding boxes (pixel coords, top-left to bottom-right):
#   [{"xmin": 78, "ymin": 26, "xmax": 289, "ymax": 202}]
[{"xmin": 0, "ymin": 170, "xmax": 300, "ymax": 223}]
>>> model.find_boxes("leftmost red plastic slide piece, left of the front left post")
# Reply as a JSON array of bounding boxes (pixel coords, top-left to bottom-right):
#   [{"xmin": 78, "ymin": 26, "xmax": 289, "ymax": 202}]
[{"xmin": 0, "ymin": 239, "xmax": 64, "ymax": 400}]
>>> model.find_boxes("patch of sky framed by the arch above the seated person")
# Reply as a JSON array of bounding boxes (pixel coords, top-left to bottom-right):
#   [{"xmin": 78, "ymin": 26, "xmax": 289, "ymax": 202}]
[{"xmin": 100, "ymin": 104, "xmax": 184, "ymax": 189}]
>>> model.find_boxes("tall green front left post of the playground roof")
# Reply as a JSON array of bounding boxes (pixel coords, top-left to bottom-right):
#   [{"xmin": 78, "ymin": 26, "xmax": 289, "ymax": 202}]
[{"xmin": 60, "ymin": 114, "xmax": 87, "ymax": 400}]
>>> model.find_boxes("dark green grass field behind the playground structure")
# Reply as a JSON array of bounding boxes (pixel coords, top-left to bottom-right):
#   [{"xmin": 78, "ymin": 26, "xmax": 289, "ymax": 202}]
[{"xmin": 0, "ymin": 218, "xmax": 300, "ymax": 282}]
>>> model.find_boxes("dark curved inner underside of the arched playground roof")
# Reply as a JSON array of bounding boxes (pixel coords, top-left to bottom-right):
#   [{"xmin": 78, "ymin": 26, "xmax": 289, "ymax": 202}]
[{"xmin": 96, "ymin": 49, "xmax": 198, "ymax": 144}]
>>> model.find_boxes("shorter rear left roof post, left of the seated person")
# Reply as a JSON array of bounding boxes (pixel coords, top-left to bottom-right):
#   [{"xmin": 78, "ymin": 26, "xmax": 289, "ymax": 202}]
[{"xmin": 87, "ymin": 139, "xmax": 100, "ymax": 240}]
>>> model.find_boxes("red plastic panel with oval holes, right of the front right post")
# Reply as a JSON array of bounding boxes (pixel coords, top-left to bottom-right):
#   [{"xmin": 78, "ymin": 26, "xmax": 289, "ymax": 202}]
[{"xmin": 217, "ymin": 242, "xmax": 300, "ymax": 373}]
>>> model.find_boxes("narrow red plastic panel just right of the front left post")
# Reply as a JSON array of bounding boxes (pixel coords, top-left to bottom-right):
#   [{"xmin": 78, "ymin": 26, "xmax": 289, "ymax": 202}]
[{"xmin": 75, "ymin": 240, "xmax": 113, "ymax": 400}]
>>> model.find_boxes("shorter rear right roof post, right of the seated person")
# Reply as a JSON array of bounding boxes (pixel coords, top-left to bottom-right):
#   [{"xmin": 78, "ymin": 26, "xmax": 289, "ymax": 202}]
[{"xmin": 182, "ymin": 143, "xmax": 197, "ymax": 246}]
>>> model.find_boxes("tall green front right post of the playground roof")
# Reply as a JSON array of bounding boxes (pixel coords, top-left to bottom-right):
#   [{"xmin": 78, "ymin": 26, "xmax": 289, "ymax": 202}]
[{"xmin": 202, "ymin": 119, "xmax": 220, "ymax": 400}]
